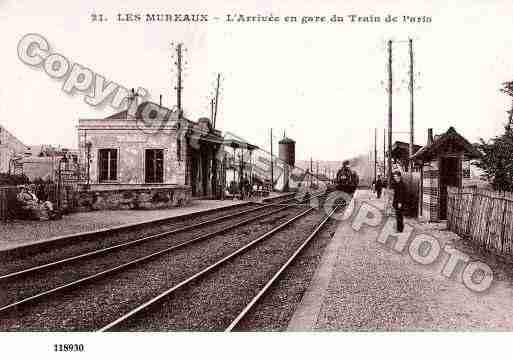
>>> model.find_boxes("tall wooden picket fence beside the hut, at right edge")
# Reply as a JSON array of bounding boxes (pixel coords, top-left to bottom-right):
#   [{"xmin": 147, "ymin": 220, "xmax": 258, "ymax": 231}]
[{"xmin": 447, "ymin": 187, "xmax": 513, "ymax": 255}]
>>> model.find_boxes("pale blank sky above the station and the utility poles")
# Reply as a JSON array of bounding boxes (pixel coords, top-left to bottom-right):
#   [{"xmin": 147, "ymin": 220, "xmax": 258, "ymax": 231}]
[{"xmin": 0, "ymin": 0, "xmax": 513, "ymax": 161}]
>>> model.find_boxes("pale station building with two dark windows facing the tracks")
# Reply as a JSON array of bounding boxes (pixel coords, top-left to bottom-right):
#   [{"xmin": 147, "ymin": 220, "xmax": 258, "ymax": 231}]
[{"xmin": 78, "ymin": 102, "xmax": 223, "ymax": 209}]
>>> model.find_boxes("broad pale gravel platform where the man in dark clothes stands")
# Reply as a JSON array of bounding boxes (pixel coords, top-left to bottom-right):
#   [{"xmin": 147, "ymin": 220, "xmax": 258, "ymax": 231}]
[{"xmin": 288, "ymin": 190, "xmax": 513, "ymax": 331}]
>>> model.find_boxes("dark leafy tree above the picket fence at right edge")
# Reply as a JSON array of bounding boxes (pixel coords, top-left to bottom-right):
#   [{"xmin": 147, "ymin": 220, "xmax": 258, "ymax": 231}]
[{"xmin": 474, "ymin": 81, "xmax": 513, "ymax": 192}]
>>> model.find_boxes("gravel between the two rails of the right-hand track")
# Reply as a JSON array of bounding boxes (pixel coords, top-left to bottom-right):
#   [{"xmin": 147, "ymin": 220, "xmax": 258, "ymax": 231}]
[{"xmin": 114, "ymin": 211, "xmax": 324, "ymax": 331}]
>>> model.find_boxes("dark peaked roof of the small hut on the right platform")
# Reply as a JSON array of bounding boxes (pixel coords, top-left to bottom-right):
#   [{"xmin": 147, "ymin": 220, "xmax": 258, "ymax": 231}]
[{"xmin": 412, "ymin": 126, "xmax": 481, "ymax": 161}]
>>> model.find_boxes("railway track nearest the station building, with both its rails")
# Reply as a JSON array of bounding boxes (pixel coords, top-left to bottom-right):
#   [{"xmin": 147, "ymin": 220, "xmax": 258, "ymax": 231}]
[{"xmin": 0, "ymin": 191, "xmax": 330, "ymax": 327}]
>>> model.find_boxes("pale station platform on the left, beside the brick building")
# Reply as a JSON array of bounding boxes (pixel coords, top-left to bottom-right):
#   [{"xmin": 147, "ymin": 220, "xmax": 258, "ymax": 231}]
[{"xmin": 0, "ymin": 200, "xmax": 244, "ymax": 252}]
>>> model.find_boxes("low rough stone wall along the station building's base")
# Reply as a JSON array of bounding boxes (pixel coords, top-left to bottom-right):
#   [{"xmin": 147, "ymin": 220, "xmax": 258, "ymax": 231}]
[{"xmin": 74, "ymin": 186, "xmax": 191, "ymax": 212}]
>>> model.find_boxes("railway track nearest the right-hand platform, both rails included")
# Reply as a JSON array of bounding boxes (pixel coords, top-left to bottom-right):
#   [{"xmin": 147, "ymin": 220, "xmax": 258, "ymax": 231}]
[{"xmin": 100, "ymin": 205, "xmax": 342, "ymax": 331}]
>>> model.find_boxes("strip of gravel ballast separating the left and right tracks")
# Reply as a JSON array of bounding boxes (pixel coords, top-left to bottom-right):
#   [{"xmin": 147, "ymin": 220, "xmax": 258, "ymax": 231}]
[{"xmin": 0, "ymin": 208, "xmax": 304, "ymax": 331}]
